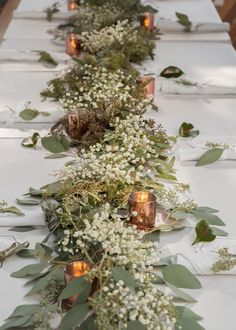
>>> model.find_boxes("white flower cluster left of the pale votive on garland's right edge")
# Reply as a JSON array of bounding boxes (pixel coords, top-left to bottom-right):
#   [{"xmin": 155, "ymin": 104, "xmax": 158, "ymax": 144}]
[{"xmin": 60, "ymin": 64, "xmax": 151, "ymax": 113}]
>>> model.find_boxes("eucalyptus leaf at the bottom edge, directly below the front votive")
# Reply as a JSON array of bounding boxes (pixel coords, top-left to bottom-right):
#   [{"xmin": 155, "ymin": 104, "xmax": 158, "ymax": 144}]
[{"xmin": 57, "ymin": 304, "xmax": 89, "ymax": 330}]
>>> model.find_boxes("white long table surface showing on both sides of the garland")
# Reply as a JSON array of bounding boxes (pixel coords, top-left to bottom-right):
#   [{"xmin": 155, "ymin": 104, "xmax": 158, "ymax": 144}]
[{"xmin": 0, "ymin": 0, "xmax": 236, "ymax": 330}]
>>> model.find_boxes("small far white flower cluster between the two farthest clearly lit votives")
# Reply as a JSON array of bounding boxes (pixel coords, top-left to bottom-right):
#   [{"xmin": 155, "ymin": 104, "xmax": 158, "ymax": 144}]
[{"xmin": 80, "ymin": 20, "xmax": 137, "ymax": 54}]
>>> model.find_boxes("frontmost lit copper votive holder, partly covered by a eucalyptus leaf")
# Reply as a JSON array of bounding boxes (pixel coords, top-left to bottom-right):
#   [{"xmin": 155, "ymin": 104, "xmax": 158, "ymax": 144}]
[{"xmin": 64, "ymin": 261, "xmax": 91, "ymax": 308}]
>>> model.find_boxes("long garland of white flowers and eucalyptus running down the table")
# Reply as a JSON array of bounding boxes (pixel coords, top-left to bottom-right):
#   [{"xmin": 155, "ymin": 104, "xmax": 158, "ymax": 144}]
[{"xmin": 0, "ymin": 0, "xmax": 225, "ymax": 330}]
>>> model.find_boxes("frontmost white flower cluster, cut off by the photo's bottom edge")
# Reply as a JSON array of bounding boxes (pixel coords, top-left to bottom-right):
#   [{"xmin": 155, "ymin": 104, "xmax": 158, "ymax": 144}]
[{"xmin": 92, "ymin": 281, "xmax": 176, "ymax": 330}]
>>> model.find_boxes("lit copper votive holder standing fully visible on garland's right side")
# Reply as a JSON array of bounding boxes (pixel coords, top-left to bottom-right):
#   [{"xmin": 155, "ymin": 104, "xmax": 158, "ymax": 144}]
[{"xmin": 129, "ymin": 191, "xmax": 157, "ymax": 231}]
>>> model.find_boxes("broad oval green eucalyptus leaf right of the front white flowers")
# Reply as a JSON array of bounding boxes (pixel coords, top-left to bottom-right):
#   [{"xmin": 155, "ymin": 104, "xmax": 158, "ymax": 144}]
[{"xmin": 161, "ymin": 265, "xmax": 201, "ymax": 289}]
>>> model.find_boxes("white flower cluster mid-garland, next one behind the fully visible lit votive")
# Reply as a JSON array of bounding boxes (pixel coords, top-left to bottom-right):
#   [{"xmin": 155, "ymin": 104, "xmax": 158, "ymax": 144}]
[{"xmin": 56, "ymin": 114, "xmax": 162, "ymax": 184}]
